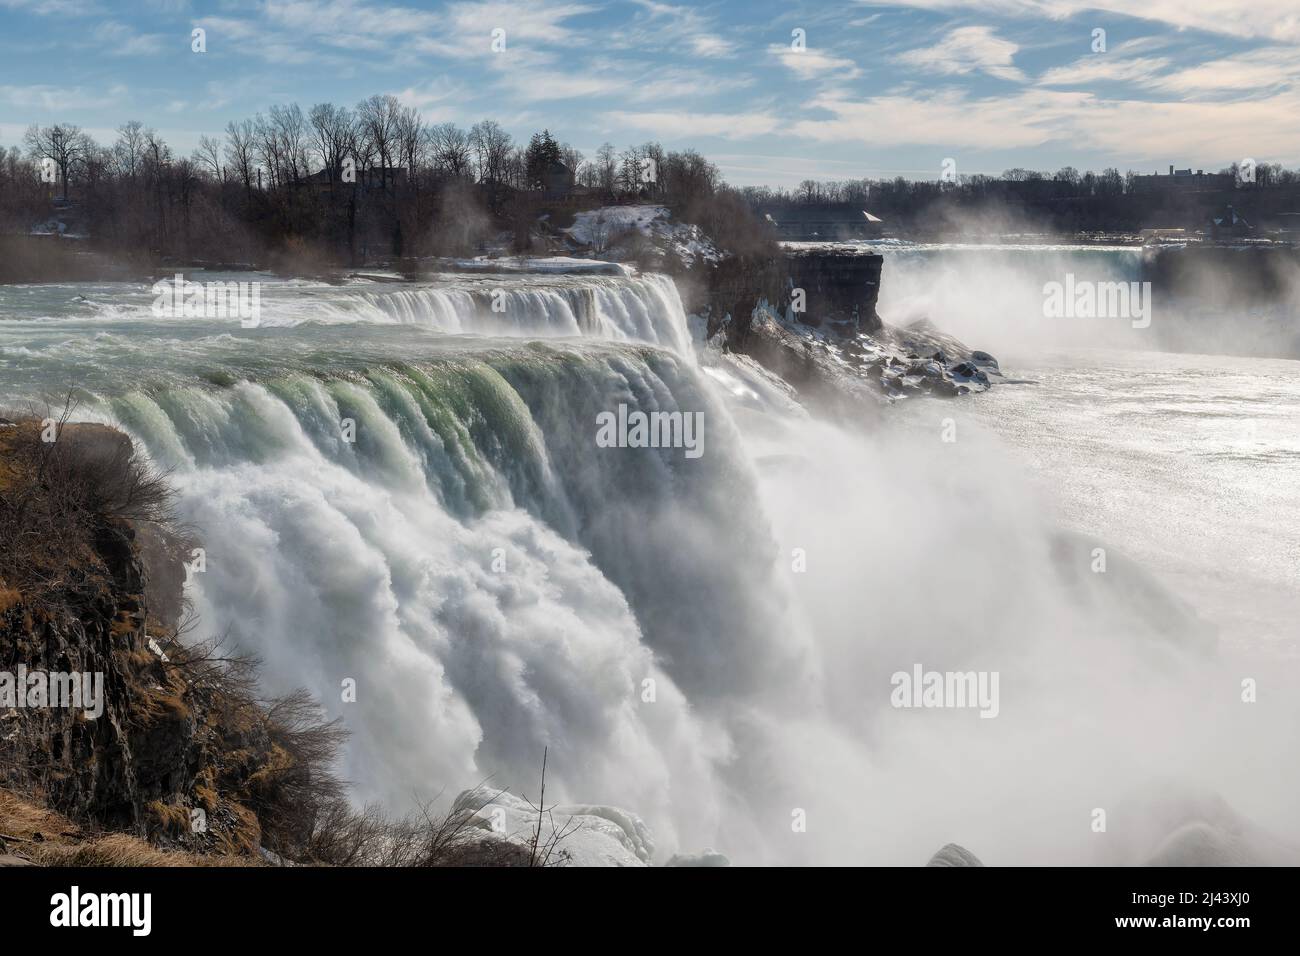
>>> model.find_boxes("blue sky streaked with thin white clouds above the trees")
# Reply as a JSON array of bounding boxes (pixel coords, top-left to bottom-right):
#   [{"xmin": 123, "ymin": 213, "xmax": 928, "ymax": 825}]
[{"xmin": 0, "ymin": 0, "xmax": 1300, "ymax": 186}]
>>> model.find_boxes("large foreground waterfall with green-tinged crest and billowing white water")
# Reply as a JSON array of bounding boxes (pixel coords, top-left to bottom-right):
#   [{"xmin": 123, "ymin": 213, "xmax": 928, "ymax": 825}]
[{"xmin": 98, "ymin": 343, "xmax": 797, "ymax": 845}]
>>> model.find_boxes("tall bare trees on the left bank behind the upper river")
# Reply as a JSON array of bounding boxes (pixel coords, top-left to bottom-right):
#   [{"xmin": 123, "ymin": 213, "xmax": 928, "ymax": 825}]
[{"xmin": 0, "ymin": 95, "xmax": 725, "ymax": 263}]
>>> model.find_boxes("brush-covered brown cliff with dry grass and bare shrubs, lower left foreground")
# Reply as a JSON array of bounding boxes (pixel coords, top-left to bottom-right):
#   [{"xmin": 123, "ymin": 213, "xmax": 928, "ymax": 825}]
[{"xmin": 0, "ymin": 408, "xmax": 572, "ymax": 866}]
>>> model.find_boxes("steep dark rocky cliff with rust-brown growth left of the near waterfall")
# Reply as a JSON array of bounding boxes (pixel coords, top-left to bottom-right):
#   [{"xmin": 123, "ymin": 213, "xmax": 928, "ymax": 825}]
[{"xmin": 0, "ymin": 420, "xmax": 340, "ymax": 855}]
